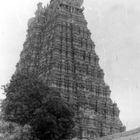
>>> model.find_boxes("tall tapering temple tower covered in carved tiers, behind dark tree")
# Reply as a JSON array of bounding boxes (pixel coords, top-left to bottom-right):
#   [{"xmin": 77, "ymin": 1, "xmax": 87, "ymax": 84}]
[{"xmin": 16, "ymin": 0, "xmax": 125, "ymax": 140}]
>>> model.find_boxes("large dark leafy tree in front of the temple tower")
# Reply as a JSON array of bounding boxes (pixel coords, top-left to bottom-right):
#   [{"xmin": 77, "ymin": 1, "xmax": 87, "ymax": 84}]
[{"xmin": 2, "ymin": 74, "xmax": 74, "ymax": 140}]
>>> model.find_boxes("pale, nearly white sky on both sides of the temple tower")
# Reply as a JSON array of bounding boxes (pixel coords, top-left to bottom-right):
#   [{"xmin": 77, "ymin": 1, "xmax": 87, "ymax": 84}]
[{"xmin": 0, "ymin": 0, "xmax": 140, "ymax": 130}]
